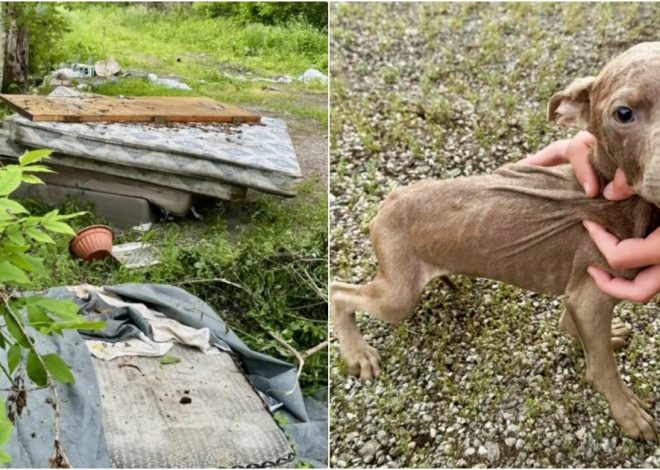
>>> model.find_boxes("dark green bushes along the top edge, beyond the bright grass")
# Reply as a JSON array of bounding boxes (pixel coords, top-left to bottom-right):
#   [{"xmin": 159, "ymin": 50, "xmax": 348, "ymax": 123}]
[{"xmin": 195, "ymin": 2, "xmax": 328, "ymax": 31}]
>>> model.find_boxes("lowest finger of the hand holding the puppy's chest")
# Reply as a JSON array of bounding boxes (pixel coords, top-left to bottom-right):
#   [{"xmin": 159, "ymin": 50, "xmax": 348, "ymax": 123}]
[{"xmin": 587, "ymin": 265, "xmax": 660, "ymax": 303}]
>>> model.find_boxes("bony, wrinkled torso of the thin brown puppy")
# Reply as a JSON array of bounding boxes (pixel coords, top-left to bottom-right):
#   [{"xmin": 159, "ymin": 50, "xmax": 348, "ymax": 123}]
[{"xmin": 372, "ymin": 165, "xmax": 650, "ymax": 294}]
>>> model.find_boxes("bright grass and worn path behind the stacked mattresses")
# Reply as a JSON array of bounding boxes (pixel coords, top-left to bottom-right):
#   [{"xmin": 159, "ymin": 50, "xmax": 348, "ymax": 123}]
[{"xmin": 52, "ymin": 3, "xmax": 328, "ymax": 126}]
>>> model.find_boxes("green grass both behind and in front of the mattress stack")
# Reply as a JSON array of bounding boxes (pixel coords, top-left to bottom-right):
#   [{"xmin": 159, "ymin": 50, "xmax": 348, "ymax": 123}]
[{"xmin": 3, "ymin": 3, "xmax": 328, "ymax": 394}]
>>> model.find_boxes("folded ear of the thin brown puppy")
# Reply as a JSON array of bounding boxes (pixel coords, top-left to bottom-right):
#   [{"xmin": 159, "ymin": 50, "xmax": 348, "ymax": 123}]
[{"xmin": 548, "ymin": 77, "xmax": 596, "ymax": 129}]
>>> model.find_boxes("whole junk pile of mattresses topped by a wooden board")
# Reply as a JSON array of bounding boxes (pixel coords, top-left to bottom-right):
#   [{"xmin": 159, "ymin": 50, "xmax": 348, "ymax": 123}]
[{"xmin": 0, "ymin": 58, "xmax": 301, "ymax": 226}]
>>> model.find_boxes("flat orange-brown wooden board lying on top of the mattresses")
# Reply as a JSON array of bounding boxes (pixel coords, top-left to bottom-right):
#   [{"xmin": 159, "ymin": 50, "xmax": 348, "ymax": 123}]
[{"xmin": 0, "ymin": 95, "xmax": 261, "ymax": 123}]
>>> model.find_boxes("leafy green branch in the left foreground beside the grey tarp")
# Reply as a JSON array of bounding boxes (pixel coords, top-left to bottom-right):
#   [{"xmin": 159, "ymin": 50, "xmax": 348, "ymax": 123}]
[{"xmin": 0, "ymin": 150, "xmax": 103, "ymax": 467}]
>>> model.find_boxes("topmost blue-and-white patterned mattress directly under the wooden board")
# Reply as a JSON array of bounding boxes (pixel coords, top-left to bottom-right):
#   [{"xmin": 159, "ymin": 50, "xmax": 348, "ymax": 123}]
[{"xmin": 0, "ymin": 91, "xmax": 302, "ymax": 197}]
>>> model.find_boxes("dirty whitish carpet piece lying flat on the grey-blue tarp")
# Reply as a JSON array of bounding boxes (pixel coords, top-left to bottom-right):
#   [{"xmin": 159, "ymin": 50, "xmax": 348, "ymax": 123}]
[{"xmin": 93, "ymin": 345, "xmax": 295, "ymax": 468}]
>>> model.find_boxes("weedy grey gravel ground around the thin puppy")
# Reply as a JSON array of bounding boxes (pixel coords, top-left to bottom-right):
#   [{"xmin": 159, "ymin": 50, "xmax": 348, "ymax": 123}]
[{"xmin": 330, "ymin": 3, "xmax": 660, "ymax": 467}]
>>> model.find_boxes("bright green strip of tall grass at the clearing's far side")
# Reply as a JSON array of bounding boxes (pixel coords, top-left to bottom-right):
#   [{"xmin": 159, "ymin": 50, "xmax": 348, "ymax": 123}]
[{"xmin": 53, "ymin": 3, "xmax": 327, "ymax": 78}]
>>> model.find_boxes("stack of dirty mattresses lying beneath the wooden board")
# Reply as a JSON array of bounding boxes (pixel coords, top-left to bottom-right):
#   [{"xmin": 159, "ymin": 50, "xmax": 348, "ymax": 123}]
[{"xmin": 0, "ymin": 88, "xmax": 301, "ymax": 224}]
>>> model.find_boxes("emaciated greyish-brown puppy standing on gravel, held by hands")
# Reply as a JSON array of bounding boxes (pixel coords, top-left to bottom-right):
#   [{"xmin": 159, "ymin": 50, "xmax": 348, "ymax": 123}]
[{"xmin": 331, "ymin": 42, "xmax": 660, "ymax": 441}]
